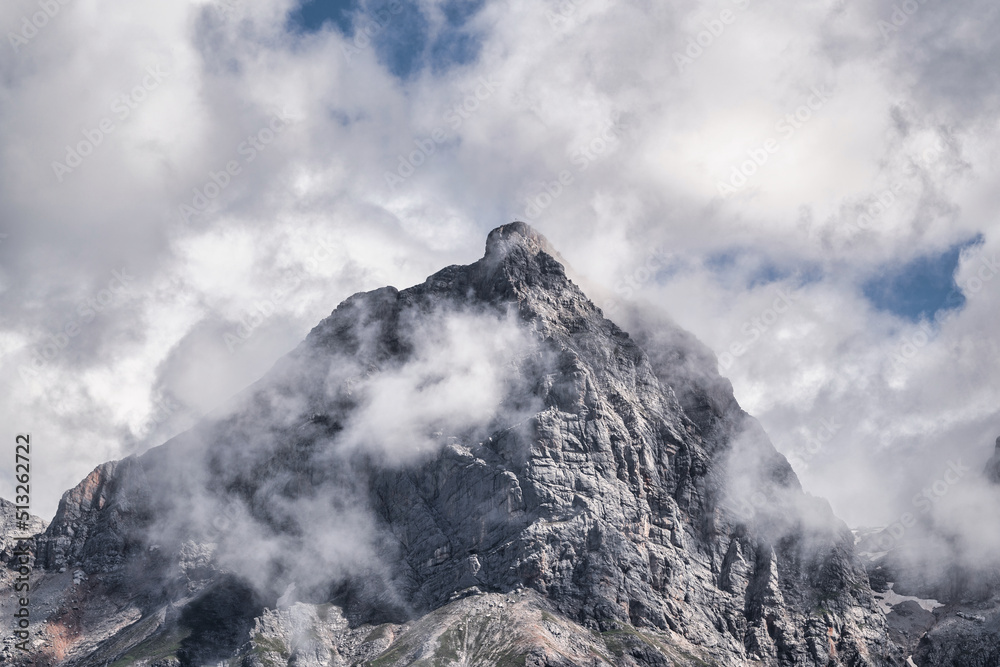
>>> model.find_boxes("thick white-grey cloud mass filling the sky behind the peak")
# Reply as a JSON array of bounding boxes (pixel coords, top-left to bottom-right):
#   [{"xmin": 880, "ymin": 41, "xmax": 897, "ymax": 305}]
[{"xmin": 0, "ymin": 0, "xmax": 1000, "ymax": 580}]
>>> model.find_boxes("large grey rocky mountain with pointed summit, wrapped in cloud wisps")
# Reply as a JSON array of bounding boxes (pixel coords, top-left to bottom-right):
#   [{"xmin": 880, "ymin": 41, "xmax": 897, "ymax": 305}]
[{"xmin": 0, "ymin": 223, "xmax": 906, "ymax": 667}]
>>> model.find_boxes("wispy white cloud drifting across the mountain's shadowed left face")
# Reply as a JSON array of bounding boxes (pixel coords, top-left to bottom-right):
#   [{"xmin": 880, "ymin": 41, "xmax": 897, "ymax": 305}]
[{"xmin": 110, "ymin": 306, "xmax": 551, "ymax": 613}]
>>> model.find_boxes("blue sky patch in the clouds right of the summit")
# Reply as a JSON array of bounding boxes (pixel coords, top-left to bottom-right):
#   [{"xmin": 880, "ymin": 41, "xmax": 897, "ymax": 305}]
[{"xmin": 862, "ymin": 236, "xmax": 983, "ymax": 322}]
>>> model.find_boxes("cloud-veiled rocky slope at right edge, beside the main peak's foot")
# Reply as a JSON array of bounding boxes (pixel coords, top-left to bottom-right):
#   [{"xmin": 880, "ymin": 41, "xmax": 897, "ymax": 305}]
[{"xmin": 858, "ymin": 438, "xmax": 1000, "ymax": 667}]
